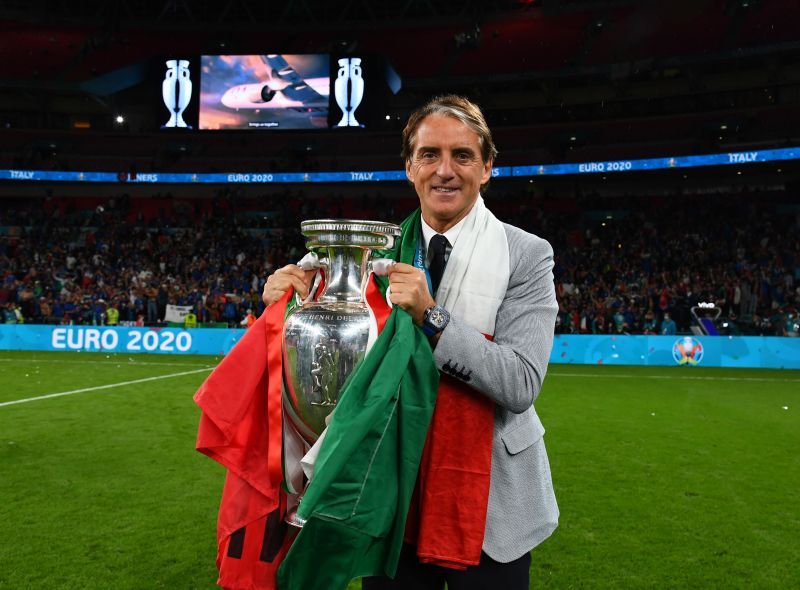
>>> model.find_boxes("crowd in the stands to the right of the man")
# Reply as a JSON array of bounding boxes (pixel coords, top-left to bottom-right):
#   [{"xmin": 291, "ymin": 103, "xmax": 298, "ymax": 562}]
[{"xmin": 523, "ymin": 194, "xmax": 800, "ymax": 336}]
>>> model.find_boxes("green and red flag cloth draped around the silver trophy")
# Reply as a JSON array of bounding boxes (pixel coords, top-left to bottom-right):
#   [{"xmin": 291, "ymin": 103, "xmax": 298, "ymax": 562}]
[{"xmin": 195, "ymin": 210, "xmax": 494, "ymax": 590}]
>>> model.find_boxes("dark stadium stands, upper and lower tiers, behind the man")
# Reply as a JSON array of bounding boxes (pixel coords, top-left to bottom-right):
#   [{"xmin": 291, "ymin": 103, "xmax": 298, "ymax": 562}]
[{"xmin": 0, "ymin": 0, "xmax": 800, "ymax": 342}]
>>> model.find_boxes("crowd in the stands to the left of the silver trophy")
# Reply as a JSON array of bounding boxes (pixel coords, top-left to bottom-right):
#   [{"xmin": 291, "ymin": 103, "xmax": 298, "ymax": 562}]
[{"xmin": 0, "ymin": 192, "xmax": 302, "ymax": 326}]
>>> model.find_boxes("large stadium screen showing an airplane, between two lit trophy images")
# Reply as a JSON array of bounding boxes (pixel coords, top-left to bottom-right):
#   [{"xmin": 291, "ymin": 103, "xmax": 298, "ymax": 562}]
[{"xmin": 199, "ymin": 54, "xmax": 330, "ymax": 130}]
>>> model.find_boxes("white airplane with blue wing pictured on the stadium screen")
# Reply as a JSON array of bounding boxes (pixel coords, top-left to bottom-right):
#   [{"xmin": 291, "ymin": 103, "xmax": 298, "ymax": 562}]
[{"xmin": 221, "ymin": 54, "xmax": 330, "ymax": 111}]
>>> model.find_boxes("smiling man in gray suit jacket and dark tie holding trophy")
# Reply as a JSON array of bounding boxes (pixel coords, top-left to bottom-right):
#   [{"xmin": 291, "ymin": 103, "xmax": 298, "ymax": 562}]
[{"xmin": 264, "ymin": 96, "xmax": 558, "ymax": 590}]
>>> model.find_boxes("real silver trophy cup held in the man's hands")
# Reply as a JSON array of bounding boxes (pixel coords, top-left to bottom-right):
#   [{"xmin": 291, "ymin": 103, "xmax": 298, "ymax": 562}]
[{"xmin": 282, "ymin": 219, "xmax": 400, "ymax": 527}]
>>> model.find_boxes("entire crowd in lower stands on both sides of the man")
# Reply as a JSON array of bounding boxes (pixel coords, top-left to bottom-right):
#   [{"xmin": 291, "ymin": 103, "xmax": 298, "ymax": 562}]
[{"xmin": 0, "ymin": 188, "xmax": 800, "ymax": 336}]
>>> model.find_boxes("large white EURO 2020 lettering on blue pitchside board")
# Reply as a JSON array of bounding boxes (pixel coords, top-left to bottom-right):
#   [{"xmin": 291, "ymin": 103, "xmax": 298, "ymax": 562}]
[{"xmin": 50, "ymin": 326, "xmax": 192, "ymax": 352}]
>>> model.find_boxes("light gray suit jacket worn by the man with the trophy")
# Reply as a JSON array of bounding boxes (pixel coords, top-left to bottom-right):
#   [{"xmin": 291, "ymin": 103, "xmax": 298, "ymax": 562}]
[{"xmin": 434, "ymin": 224, "xmax": 558, "ymax": 563}]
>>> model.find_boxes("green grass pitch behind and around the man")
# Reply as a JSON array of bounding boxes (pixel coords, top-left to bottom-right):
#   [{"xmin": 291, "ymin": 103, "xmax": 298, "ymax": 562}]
[{"xmin": 0, "ymin": 352, "xmax": 800, "ymax": 590}]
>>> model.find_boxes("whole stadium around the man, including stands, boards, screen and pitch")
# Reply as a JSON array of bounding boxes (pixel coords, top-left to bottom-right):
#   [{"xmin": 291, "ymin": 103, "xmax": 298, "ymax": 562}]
[{"xmin": 0, "ymin": 0, "xmax": 800, "ymax": 590}]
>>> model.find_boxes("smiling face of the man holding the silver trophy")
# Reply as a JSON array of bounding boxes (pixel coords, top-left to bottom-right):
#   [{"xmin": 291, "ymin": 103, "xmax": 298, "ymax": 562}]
[{"xmin": 406, "ymin": 114, "xmax": 492, "ymax": 233}]
